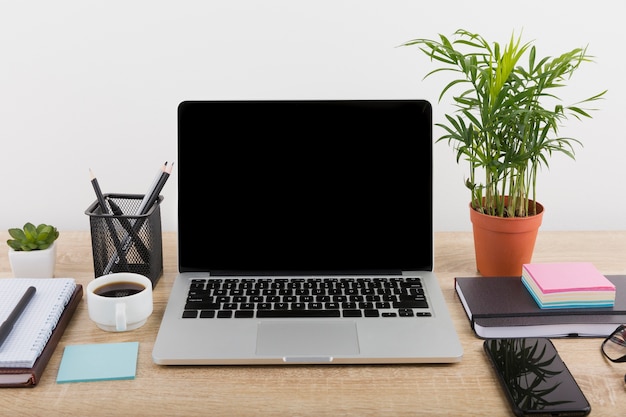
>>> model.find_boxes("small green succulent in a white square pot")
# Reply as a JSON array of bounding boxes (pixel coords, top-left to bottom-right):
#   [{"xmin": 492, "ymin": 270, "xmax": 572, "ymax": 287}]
[{"xmin": 7, "ymin": 223, "xmax": 59, "ymax": 278}]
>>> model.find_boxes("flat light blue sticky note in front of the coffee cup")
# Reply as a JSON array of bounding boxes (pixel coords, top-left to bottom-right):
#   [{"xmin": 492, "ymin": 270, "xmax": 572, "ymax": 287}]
[{"xmin": 57, "ymin": 342, "xmax": 139, "ymax": 383}]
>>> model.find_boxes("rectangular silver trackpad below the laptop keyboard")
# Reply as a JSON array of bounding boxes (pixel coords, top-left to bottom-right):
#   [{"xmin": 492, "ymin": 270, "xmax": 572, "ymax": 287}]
[{"xmin": 256, "ymin": 320, "xmax": 359, "ymax": 361}]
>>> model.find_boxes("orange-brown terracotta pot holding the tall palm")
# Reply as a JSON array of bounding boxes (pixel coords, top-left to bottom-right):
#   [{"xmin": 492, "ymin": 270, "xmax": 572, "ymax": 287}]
[{"xmin": 469, "ymin": 203, "xmax": 543, "ymax": 276}]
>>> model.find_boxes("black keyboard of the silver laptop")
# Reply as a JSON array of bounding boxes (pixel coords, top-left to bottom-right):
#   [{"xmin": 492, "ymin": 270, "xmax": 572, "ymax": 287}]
[{"xmin": 182, "ymin": 276, "xmax": 431, "ymax": 318}]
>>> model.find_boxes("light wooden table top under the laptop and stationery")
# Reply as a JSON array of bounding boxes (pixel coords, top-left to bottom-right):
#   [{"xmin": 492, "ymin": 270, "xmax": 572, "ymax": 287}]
[{"xmin": 0, "ymin": 231, "xmax": 626, "ymax": 417}]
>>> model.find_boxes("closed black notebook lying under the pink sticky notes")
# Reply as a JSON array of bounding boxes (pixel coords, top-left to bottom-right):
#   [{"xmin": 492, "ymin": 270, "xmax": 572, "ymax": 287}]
[{"xmin": 455, "ymin": 275, "xmax": 626, "ymax": 338}]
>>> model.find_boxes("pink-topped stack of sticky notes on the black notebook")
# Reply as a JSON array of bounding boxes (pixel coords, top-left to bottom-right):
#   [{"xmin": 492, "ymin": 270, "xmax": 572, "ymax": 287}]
[{"xmin": 522, "ymin": 262, "xmax": 615, "ymax": 308}]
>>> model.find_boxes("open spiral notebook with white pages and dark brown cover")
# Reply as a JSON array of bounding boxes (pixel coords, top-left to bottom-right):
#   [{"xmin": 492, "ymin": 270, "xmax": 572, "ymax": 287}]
[{"xmin": 0, "ymin": 278, "xmax": 82, "ymax": 386}]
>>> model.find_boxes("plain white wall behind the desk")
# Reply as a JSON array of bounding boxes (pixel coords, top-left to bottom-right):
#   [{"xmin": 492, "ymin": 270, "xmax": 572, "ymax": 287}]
[{"xmin": 0, "ymin": 0, "xmax": 626, "ymax": 231}]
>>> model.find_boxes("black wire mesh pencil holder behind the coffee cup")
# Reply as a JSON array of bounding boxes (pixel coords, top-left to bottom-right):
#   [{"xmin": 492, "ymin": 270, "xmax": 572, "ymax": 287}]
[{"xmin": 85, "ymin": 194, "xmax": 163, "ymax": 288}]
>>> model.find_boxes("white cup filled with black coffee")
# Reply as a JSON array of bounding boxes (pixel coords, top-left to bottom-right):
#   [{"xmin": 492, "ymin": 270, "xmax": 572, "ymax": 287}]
[{"xmin": 87, "ymin": 272, "xmax": 152, "ymax": 332}]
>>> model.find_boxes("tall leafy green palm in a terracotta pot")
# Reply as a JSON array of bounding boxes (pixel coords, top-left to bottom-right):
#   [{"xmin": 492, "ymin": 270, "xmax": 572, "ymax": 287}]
[{"xmin": 403, "ymin": 29, "xmax": 606, "ymax": 276}]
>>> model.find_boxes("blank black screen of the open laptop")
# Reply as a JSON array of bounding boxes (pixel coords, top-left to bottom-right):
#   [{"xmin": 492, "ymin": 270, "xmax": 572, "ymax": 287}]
[{"xmin": 177, "ymin": 100, "xmax": 433, "ymax": 275}]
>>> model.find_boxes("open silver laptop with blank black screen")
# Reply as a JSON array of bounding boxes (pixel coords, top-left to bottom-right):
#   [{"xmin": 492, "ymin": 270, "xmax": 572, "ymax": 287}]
[{"xmin": 152, "ymin": 100, "xmax": 463, "ymax": 365}]
